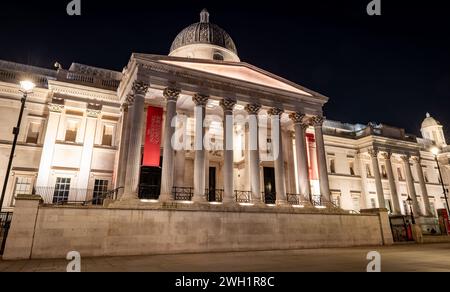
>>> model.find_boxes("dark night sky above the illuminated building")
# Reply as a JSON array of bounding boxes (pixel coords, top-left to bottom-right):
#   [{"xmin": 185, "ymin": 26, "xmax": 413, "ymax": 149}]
[{"xmin": 0, "ymin": 0, "xmax": 450, "ymax": 138}]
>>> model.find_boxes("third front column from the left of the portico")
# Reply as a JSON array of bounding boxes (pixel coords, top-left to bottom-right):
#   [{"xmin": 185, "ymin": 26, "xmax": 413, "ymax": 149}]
[{"xmin": 192, "ymin": 94, "xmax": 208, "ymax": 202}]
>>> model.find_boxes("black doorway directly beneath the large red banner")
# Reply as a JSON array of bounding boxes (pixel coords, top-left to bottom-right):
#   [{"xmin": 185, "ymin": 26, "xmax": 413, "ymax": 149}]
[{"xmin": 139, "ymin": 158, "xmax": 162, "ymax": 200}]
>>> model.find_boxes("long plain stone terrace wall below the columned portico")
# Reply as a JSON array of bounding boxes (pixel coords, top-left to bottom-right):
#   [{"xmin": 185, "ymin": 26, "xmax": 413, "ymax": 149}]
[{"xmin": 4, "ymin": 197, "xmax": 392, "ymax": 259}]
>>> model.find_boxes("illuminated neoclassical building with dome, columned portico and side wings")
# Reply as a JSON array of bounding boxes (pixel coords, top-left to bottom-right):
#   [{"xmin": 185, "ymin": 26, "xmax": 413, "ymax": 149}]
[{"xmin": 0, "ymin": 10, "xmax": 450, "ymax": 238}]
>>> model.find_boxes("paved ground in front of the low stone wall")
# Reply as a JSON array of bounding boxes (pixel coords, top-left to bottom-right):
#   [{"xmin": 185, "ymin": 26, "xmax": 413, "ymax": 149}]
[{"xmin": 0, "ymin": 243, "xmax": 450, "ymax": 272}]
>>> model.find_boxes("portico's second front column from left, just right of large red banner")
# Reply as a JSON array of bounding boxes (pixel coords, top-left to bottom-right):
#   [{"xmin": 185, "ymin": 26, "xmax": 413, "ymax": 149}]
[{"xmin": 159, "ymin": 88, "xmax": 180, "ymax": 202}]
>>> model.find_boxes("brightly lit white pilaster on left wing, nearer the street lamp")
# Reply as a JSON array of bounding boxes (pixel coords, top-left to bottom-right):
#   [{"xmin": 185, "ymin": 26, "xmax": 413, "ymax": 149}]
[{"xmin": 36, "ymin": 104, "xmax": 64, "ymax": 187}]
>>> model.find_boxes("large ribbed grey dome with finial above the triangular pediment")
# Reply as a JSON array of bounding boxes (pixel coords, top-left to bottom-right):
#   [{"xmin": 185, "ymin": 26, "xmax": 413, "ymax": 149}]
[{"xmin": 169, "ymin": 9, "xmax": 238, "ymax": 58}]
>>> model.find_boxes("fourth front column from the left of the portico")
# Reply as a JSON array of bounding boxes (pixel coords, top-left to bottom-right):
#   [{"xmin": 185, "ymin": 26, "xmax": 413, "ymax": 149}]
[{"xmin": 220, "ymin": 99, "xmax": 236, "ymax": 203}]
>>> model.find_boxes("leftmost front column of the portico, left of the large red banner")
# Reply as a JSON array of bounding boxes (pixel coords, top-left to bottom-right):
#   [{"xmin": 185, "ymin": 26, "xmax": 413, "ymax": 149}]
[{"xmin": 121, "ymin": 81, "xmax": 148, "ymax": 201}]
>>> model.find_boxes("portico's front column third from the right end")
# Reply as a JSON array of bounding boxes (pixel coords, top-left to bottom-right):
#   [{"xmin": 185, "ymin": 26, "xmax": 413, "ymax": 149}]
[{"xmin": 268, "ymin": 108, "xmax": 287, "ymax": 205}]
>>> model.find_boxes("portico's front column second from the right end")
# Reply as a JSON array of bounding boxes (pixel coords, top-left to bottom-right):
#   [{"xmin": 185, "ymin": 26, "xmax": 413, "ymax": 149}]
[{"xmin": 289, "ymin": 113, "xmax": 311, "ymax": 200}]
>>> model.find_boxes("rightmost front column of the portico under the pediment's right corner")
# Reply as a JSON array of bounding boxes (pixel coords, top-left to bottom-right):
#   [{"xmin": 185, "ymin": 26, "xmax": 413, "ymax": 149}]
[{"xmin": 311, "ymin": 116, "xmax": 330, "ymax": 201}]
